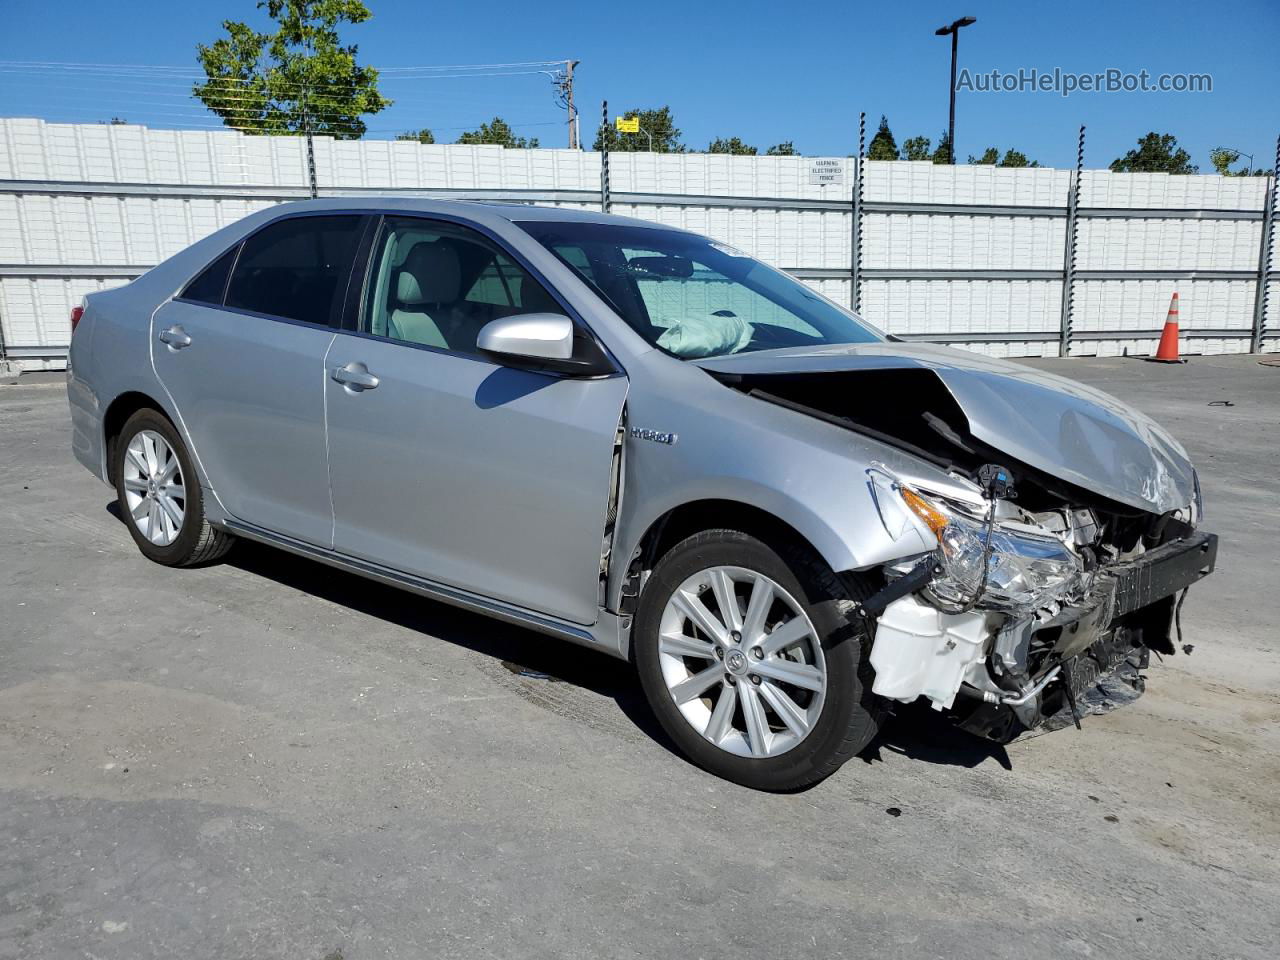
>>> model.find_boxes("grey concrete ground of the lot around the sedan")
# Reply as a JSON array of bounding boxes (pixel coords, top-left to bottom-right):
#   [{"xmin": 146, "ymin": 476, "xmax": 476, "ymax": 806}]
[{"xmin": 0, "ymin": 357, "xmax": 1280, "ymax": 960}]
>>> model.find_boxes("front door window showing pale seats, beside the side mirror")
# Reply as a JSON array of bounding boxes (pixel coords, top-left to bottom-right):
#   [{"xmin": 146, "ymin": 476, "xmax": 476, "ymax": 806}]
[{"xmin": 361, "ymin": 216, "xmax": 564, "ymax": 355}]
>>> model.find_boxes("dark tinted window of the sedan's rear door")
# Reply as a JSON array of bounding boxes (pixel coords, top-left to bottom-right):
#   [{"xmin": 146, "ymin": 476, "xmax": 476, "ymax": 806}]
[{"xmin": 227, "ymin": 215, "xmax": 361, "ymax": 324}]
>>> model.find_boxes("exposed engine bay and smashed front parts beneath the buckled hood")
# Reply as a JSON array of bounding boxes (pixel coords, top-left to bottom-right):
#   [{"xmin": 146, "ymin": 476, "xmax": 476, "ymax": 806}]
[{"xmin": 719, "ymin": 367, "xmax": 1217, "ymax": 742}]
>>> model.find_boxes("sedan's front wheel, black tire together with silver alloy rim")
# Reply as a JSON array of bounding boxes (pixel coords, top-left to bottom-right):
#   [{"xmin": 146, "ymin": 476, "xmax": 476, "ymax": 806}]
[{"xmin": 634, "ymin": 530, "xmax": 882, "ymax": 791}]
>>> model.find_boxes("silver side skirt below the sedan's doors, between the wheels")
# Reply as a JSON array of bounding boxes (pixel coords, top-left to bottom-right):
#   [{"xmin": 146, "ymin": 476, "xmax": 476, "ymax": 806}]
[{"xmin": 218, "ymin": 518, "xmax": 627, "ymax": 659}]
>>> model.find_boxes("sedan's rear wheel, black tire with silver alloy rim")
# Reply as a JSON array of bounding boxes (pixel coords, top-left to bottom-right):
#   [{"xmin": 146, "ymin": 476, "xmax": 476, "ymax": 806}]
[{"xmin": 113, "ymin": 408, "xmax": 236, "ymax": 567}]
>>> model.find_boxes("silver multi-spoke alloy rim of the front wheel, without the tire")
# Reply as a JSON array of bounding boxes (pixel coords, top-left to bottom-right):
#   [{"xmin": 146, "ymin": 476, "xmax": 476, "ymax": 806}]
[{"xmin": 658, "ymin": 566, "xmax": 827, "ymax": 758}]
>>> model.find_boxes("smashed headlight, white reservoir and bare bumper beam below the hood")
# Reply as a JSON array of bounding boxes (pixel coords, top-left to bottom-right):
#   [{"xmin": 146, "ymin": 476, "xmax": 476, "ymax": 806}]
[{"xmin": 863, "ymin": 465, "xmax": 1217, "ymax": 742}]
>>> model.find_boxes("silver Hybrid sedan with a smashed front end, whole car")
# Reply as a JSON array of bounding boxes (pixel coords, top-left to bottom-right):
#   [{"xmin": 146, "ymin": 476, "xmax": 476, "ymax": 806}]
[{"xmin": 68, "ymin": 198, "xmax": 1216, "ymax": 790}]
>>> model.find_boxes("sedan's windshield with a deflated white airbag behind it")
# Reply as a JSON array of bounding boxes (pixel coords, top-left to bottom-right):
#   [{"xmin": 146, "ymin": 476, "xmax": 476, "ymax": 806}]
[{"xmin": 520, "ymin": 220, "xmax": 883, "ymax": 358}]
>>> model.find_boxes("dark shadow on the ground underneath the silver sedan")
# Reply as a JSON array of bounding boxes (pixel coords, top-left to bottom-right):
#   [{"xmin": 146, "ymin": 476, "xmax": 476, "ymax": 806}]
[{"xmin": 106, "ymin": 500, "xmax": 1012, "ymax": 786}]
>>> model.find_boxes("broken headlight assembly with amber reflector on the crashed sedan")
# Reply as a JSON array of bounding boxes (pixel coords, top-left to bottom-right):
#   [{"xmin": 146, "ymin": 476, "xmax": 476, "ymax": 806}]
[{"xmin": 897, "ymin": 483, "xmax": 1084, "ymax": 612}]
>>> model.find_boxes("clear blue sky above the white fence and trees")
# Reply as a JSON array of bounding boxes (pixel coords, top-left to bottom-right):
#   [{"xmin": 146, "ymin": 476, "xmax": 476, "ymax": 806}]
[{"xmin": 0, "ymin": 0, "xmax": 1280, "ymax": 173}]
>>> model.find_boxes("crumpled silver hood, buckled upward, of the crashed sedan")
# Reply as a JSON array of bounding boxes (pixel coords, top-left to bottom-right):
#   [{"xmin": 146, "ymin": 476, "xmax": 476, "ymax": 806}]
[{"xmin": 691, "ymin": 343, "xmax": 1196, "ymax": 513}]
